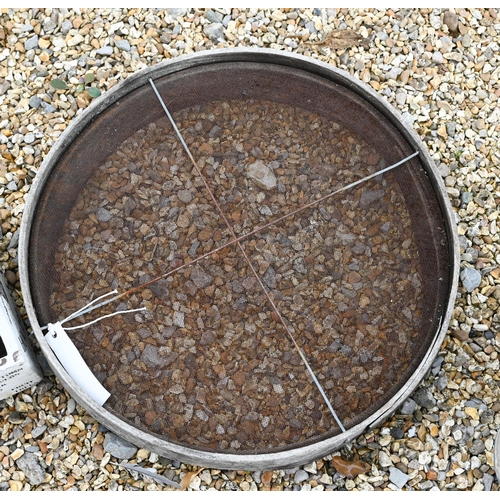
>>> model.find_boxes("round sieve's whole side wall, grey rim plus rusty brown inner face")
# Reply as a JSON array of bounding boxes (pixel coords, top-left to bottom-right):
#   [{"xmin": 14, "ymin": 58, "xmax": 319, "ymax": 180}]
[{"xmin": 19, "ymin": 49, "xmax": 459, "ymax": 470}]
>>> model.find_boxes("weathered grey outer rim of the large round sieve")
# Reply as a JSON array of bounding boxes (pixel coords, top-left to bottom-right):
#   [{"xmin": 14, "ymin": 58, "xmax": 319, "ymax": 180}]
[{"xmin": 19, "ymin": 49, "xmax": 460, "ymax": 470}]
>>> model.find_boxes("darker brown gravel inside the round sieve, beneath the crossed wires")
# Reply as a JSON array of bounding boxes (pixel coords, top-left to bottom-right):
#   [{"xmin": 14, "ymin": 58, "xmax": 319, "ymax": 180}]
[{"xmin": 47, "ymin": 100, "xmax": 423, "ymax": 452}]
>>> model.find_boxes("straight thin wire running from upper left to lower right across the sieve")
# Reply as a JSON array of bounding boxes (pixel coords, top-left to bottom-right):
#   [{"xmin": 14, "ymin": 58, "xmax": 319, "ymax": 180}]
[{"xmin": 149, "ymin": 78, "xmax": 346, "ymax": 432}]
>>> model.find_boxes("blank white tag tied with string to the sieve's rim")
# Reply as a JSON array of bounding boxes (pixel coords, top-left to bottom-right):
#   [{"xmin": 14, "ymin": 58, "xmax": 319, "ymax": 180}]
[{"xmin": 45, "ymin": 323, "xmax": 111, "ymax": 406}]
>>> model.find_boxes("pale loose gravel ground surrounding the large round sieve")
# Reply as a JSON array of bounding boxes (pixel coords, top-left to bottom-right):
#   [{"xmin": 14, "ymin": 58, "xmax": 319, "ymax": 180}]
[{"xmin": 0, "ymin": 8, "xmax": 500, "ymax": 491}]
